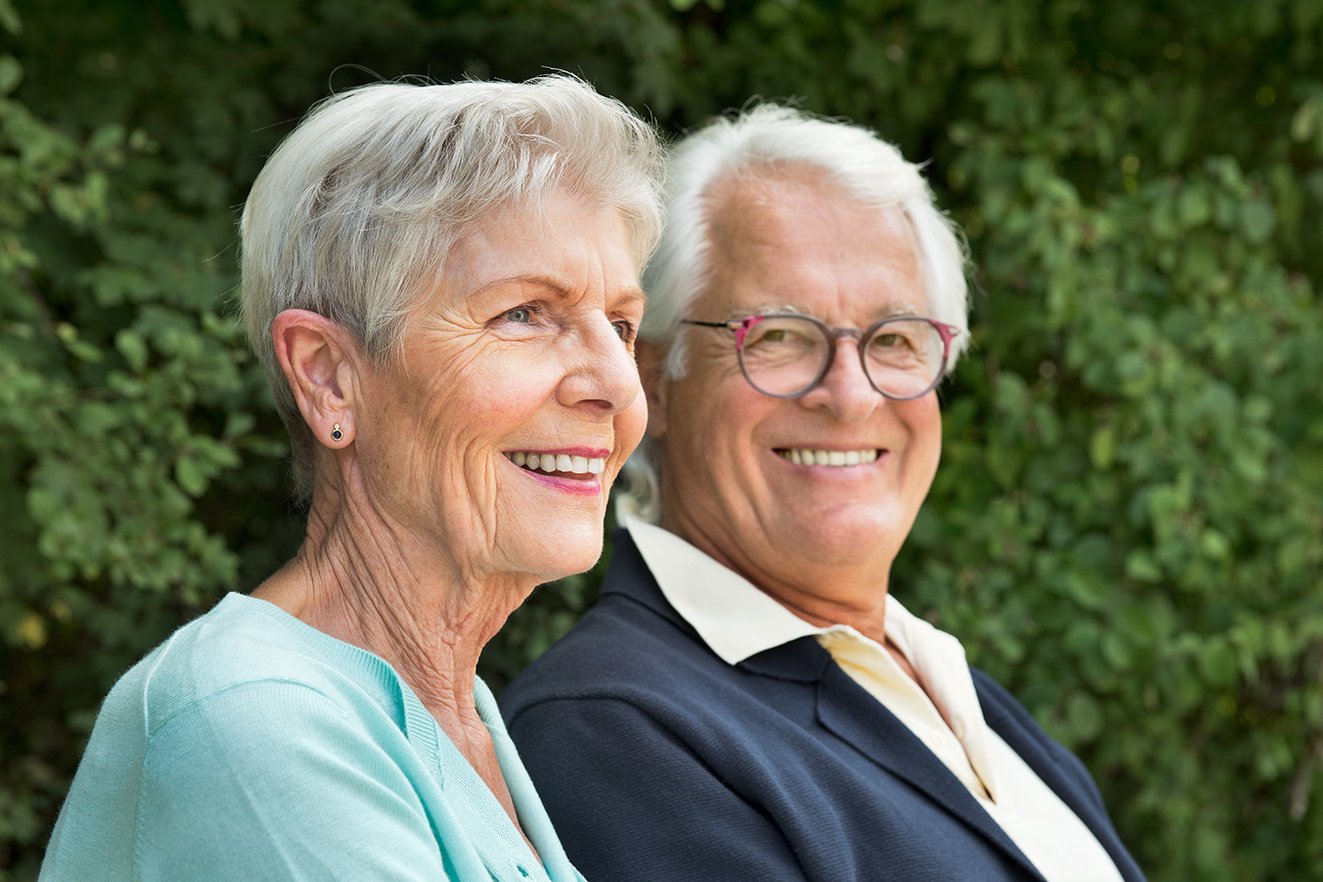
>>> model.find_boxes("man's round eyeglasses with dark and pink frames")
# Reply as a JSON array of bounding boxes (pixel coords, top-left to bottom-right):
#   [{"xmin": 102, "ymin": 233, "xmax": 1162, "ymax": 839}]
[{"xmin": 680, "ymin": 312, "xmax": 960, "ymax": 401}]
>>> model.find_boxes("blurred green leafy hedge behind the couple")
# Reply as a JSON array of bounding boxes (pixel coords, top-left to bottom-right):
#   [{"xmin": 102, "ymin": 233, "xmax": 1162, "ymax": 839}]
[{"xmin": 0, "ymin": 0, "xmax": 1323, "ymax": 882}]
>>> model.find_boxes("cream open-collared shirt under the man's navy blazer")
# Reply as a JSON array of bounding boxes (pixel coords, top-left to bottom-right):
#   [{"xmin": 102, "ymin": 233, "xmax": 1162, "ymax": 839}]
[{"xmin": 624, "ymin": 518, "xmax": 1121, "ymax": 882}]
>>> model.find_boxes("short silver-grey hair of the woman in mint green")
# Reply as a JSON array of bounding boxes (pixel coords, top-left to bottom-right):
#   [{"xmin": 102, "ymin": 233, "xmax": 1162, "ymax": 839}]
[{"xmin": 241, "ymin": 75, "xmax": 662, "ymax": 499}]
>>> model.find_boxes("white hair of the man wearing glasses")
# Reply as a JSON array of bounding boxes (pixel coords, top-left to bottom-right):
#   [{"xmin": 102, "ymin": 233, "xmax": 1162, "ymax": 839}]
[{"xmin": 620, "ymin": 103, "xmax": 968, "ymax": 521}]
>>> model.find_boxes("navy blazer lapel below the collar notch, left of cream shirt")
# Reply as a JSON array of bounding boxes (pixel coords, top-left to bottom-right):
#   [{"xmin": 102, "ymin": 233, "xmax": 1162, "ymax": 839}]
[{"xmin": 818, "ymin": 658, "xmax": 1043, "ymax": 879}]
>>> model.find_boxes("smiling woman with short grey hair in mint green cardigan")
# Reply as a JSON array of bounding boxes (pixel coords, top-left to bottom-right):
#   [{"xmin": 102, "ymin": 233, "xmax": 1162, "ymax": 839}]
[{"xmin": 42, "ymin": 77, "xmax": 660, "ymax": 882}]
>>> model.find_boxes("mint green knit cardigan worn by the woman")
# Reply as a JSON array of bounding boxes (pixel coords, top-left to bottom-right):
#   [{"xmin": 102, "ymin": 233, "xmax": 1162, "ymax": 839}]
[{"xmin": 41, "ymin": 594, "xmax": 582, "ymax": 882}]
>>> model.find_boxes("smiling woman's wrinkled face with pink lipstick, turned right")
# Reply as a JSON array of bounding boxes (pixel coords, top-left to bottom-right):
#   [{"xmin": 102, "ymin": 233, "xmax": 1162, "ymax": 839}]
[{"xmin": 356, "ymin": 190, "xmax": 647, "ymax": 581}]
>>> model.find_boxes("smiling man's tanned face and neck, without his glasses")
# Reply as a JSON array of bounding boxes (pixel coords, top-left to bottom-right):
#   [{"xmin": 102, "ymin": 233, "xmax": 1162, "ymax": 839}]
[{"xmin": 644, "ymin": 173, "xmax": 941, "ymax": 620}]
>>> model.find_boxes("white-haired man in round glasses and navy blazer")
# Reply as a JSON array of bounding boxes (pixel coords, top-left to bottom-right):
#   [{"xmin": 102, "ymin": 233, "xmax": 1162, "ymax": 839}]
[{"xmin": 503, "ymin": 106, "xmax": 1143, "ymax": 882}]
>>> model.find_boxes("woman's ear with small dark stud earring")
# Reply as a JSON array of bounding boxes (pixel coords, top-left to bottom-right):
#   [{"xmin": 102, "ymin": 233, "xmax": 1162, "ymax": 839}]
[{"xmin": 271, "ymin": 309, "xmax": 360, "ymax": 448}]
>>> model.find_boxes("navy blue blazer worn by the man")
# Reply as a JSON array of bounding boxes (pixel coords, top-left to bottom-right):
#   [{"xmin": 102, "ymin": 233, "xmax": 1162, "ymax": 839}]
[{"xmin": 501, "ymin": 530, "xmax": 1143, "ymax": 882}]
